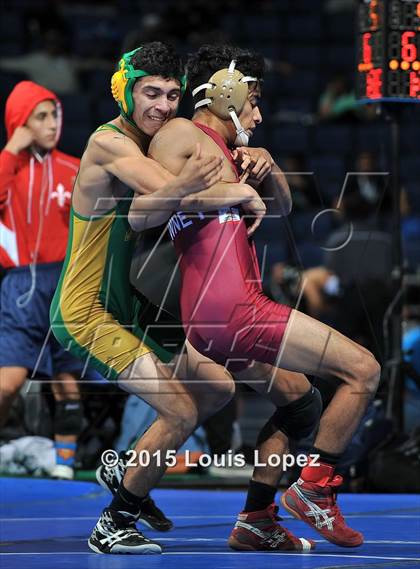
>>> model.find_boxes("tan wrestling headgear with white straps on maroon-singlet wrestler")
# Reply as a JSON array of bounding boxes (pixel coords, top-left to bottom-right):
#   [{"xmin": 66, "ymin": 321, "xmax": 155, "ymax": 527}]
[{"xmin": 192, "ymin": 60, "xmax": 258, "ymax": 146}]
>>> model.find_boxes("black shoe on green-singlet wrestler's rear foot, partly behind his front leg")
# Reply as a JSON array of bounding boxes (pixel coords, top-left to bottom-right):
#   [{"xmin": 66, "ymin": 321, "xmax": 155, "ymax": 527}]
[{"xmin": 96, "ymin": 452, "xmax": 173, "ymax": 531}]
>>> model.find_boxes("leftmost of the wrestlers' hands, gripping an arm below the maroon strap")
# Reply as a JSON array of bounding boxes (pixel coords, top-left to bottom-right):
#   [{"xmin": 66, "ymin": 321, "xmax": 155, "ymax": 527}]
[{"xmin": 178, "ymin": 142, "xmax": 224, "ymax": 195}]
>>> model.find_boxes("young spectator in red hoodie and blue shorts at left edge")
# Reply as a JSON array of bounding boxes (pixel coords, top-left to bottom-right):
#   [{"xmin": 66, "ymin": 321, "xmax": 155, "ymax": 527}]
[{"xmin": 0, "ymin": 81, "xmax": 83, "ymax": 478}]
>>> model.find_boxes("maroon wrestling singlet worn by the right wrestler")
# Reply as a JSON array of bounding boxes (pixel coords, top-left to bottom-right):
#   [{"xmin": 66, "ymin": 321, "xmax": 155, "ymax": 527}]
[{"xmin": 168, "ymin": 123, "xmax": 291, "ymax": 371}]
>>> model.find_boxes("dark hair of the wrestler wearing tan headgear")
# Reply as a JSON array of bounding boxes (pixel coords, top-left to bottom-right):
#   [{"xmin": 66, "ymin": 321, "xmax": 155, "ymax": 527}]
[{"xmin": 187, "ymin": 45, "xmax": 265, "ymax": 96}]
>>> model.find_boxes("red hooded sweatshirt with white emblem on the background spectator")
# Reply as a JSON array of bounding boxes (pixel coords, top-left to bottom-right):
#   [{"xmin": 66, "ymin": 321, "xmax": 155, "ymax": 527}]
[{"xmin": 0, "ymin": 81, "xmax": 80, "ymax": 268}]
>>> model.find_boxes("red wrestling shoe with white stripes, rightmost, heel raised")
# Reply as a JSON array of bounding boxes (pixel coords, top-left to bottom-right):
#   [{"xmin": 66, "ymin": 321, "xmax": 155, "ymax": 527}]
[{"xmin": 281, "ymin": 476, "xmax": 363, "ymax": 547}]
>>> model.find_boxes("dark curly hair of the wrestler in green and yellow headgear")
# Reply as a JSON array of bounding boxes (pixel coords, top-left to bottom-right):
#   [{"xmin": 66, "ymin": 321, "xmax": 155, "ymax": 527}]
[{"xmin": 131, "ymin": 41, "xmax": 184, "ymax": 79}]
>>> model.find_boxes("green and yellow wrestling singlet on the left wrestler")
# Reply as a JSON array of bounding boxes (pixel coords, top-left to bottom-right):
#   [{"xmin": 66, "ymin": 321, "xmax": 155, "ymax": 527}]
[{"xmin": 50, "ymin": 125, "xmax": 173, "ymax": 379}]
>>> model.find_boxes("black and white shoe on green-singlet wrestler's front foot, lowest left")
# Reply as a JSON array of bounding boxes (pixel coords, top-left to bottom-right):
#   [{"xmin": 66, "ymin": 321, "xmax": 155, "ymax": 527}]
[{"xmin": 88, "ymin": 508, "xmax": 162, "ymax": 555}]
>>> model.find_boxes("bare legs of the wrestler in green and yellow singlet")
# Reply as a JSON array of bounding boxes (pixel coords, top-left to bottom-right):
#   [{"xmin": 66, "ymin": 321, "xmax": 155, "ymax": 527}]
[{"xmin": 118, "ymin": 346, "xmax": 234, "ymax": 496}]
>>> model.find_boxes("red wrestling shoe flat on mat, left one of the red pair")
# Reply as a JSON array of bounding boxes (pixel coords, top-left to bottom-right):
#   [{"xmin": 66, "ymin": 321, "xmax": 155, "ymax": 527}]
[{"xmin": 228, "ymin": 504, "xmax": 315, "ymax": 553}]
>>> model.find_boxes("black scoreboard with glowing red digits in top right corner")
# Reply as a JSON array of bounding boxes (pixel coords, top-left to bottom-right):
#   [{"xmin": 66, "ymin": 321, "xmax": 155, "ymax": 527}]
[{"xmin": 356, "ymin": 0, "xmax": 420, "ymax": 102}]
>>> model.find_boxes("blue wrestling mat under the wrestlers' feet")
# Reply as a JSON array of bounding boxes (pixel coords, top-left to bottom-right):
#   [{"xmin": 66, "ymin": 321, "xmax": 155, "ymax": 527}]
[{"xmin": 0, "ymin": 478, "xmax": 420, "ymax": 569}]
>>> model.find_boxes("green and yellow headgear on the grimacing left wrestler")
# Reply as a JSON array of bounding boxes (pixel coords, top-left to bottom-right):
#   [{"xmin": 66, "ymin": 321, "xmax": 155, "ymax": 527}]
[{"xmin": 111, "ymin": 47, "xmax": 187, "ymax": 128}]
